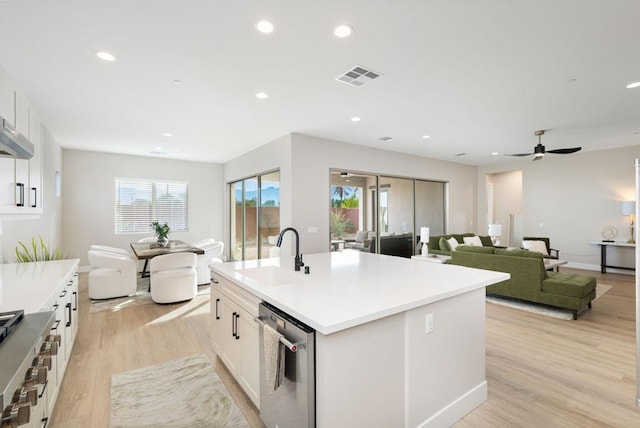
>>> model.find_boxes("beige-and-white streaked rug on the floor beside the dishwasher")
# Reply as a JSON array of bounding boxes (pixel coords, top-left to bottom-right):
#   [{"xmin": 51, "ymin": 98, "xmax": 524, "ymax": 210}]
[{"xmin": 109, "ymin": 354, "xmax": 249, "ymax": 428}]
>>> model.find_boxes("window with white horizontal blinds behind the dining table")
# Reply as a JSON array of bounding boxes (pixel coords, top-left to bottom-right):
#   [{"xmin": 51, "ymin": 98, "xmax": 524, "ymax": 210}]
[{"xmin": 115, "ymin": 179, "xmax": 189, "ymax": 234}]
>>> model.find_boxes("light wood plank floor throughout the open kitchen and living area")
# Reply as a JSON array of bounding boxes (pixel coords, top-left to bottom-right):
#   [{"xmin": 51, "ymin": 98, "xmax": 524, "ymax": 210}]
[{"xmin": 49, "ymin": 268, "xmax": 640, "ymax": 428}]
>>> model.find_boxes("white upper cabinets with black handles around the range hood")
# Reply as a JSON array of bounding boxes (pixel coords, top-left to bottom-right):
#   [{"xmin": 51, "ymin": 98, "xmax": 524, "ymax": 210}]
[{"xmin": 0, "ymin": 68, "xmax": 42, "ymax": 214}]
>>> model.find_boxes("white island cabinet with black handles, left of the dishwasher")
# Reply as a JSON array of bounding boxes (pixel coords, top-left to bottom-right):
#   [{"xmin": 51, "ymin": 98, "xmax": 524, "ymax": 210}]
[{"xmin": 211, "ymin": 274, "xmax": 261, "ymax": 408}]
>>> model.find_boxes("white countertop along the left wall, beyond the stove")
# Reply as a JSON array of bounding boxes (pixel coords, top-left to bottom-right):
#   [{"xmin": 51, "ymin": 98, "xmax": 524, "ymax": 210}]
[{"xmin": 0, "ymin": 259, "xmax": 78, "ymax": 314}]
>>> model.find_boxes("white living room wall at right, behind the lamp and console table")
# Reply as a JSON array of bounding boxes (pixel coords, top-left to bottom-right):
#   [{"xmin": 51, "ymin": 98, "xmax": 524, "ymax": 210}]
[{"xmin": 478, "ymin": 145, "xmax": 640, "ymax": 270}]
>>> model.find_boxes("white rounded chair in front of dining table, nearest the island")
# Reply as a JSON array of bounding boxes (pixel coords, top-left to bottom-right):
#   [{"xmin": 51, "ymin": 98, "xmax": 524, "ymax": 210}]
[{"xmin": 149, "ymin": 253, "xmax": 198, "ymax": 303}]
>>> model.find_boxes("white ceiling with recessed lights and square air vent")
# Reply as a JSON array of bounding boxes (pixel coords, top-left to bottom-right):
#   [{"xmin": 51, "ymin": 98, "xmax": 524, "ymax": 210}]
[{"xmin": 0, "ymin": 0, "xmax": 640, "ymax": 165}]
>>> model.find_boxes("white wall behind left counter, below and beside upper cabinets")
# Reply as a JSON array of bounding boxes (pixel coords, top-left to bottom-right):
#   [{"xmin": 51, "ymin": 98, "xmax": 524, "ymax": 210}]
[{"xmin": 0, "ymin": 128, "xmax": 66, "ymax": 263}]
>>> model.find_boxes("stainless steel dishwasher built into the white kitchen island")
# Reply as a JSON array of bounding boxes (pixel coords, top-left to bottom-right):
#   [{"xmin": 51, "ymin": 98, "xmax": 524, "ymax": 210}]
[{"xmin": 258, "ymin": 302, "xmax": 316, "ymax": 428}]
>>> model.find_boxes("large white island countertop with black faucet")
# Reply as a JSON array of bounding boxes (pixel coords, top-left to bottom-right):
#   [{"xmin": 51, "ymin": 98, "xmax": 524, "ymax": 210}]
[{"xmin": 210, "ymin": 250, "xmax": 509, "ymax": 334}]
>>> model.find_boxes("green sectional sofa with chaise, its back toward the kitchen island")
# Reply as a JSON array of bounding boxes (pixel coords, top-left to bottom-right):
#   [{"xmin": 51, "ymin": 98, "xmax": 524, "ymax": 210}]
[{"xmin": 451, "ymin": 245, "xmax": 596, "ymax": 320}]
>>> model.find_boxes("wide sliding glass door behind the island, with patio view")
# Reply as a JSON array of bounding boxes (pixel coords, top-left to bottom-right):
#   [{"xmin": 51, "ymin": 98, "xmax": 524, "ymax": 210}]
[{"xmin": 329, "ymin": 171, "xmax": 447, "ymax": 257}]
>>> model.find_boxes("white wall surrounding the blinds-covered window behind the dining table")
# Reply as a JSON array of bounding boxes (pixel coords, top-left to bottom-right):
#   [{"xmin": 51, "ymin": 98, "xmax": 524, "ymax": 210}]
[{"xmin": 62, "ymin": 150, "xmax": 226, "ymax": 265}]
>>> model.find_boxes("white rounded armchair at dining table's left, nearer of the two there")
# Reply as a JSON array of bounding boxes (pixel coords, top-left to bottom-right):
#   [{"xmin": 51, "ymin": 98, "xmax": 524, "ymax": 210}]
[{"xmin": 87, "ymin": 249, "xmax": 137, "ymax": 299}]
